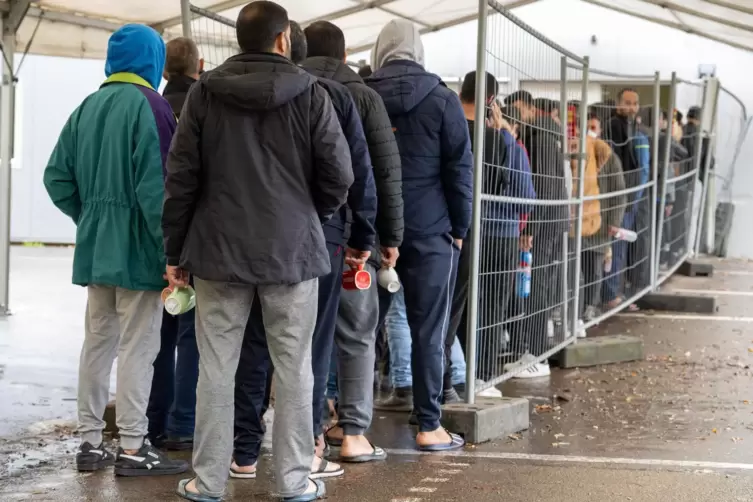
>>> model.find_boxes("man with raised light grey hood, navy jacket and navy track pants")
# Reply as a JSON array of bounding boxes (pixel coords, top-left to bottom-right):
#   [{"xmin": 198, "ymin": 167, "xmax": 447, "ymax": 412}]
[{"xmin": 366, "ymin": 20, "xmax": 473, "ymax": 451}]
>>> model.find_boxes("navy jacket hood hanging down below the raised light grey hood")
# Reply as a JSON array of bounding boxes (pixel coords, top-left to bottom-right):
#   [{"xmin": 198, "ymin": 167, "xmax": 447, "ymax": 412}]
[{"xmin": 367, "ymin": 60, "xmax": 444, "ymax": 115}]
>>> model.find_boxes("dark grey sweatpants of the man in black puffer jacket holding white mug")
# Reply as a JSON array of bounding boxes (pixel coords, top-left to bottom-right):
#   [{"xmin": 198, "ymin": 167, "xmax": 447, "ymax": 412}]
[{"xmin": 335, "ymin": 263, "xmax": 379, "ymax": 436}]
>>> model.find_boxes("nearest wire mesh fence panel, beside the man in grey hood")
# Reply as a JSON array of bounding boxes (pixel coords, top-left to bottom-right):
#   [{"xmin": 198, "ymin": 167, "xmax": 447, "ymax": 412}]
[{"xmin": 466, "ymin": 1, "xmax": 588, "ymax": 400}]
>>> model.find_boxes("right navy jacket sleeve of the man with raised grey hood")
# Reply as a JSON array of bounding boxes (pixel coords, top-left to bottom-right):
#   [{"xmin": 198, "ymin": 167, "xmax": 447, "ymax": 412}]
[{"xmin": 440, "ymin": 92, "xmax": 473, "ymax": 239}]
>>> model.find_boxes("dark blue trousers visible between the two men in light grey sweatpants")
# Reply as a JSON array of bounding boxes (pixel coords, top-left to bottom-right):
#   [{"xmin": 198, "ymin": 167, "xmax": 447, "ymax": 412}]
[{"xmin": 146, "ymin": 310, "xmax": 199, "ymax": 439}]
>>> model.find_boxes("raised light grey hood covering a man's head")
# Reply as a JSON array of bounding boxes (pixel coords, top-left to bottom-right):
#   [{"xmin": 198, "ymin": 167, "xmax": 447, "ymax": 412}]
[{"xmin": 371, "ymin": 19, "xmax": 424, "ymax": 71}]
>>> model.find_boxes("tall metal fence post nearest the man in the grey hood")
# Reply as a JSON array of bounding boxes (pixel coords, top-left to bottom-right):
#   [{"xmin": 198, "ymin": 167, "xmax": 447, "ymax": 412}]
[{"xmin": 465, "ymin": 0, "xmax": 488, "ymax": 404}]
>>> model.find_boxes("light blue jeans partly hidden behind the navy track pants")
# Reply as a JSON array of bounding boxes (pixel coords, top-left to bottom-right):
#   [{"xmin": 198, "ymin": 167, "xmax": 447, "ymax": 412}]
[{"xmin": 385, "ymin": 289, "xmax": 465, "ymax": 388}]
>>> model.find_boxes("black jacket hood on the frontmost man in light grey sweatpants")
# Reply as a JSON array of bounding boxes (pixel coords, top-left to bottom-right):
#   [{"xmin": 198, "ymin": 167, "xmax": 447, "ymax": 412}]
[{"xmin": 200, "ymin": 54, "xmax": 316, "ymax": 110}]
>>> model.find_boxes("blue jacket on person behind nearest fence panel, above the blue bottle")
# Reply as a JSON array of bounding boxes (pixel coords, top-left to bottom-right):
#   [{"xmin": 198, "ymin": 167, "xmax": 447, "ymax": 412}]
[{"xmin": 482, "ymin": 131, "xmax": 536, "ymax": 237}]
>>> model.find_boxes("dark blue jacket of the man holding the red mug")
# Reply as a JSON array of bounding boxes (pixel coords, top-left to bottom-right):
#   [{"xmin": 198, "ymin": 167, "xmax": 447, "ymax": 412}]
[{"xmin": 317, "ymin": 78, "xmax": 377, "ymax": 251}]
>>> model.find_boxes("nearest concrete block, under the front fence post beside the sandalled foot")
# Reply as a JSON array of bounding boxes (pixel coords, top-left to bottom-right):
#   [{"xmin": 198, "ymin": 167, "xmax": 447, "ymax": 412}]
[{"xmin": 442, "ymin": 397, "xmax": 530, "ymax": 444}]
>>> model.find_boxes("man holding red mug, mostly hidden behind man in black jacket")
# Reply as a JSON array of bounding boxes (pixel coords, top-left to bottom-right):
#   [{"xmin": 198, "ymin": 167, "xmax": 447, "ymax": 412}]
[{"xmin": 230, "ymin": 21, "xmax": 377, "ymax": 479}]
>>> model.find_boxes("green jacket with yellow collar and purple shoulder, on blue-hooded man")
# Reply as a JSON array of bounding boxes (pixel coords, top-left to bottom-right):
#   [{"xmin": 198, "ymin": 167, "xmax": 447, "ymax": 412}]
[{"xmin": 44, "ymin": 73, "xmax": 176, "ymax": 291}]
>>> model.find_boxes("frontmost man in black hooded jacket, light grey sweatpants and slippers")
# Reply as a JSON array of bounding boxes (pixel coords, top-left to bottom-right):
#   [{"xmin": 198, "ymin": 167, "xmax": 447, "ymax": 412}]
[{"xmin": 162, "ymin": 1, "xmax": 353, "ymax": 502}]
